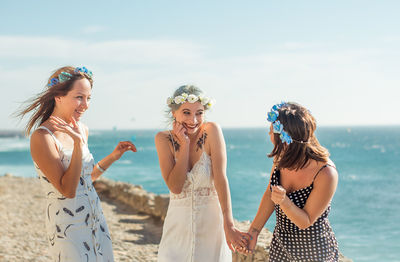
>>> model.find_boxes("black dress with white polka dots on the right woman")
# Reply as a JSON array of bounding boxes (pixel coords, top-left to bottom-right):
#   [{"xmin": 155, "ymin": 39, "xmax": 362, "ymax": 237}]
[{"xmin": 269, "ymin": 165, "xmax": 339, "ymax": 262}]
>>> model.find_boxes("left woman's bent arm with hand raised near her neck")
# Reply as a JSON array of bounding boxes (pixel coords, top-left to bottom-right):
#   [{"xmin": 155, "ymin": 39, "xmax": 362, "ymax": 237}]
[{"xmin": 30, "ymin": 117, "xmax": 83, "ymax": 198}]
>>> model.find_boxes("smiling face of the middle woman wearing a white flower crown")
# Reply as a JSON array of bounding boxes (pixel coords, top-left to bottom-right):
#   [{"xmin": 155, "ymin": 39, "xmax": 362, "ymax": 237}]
[{"xmin": 172, "ymin": 102, "xmax": 204, "ymax": 135}]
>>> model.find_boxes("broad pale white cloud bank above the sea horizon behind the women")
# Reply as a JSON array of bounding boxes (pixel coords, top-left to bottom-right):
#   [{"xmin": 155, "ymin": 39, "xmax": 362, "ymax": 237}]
[{"xmin": 0, "ymin": 36, "xmax": 400, "ymax": 128}]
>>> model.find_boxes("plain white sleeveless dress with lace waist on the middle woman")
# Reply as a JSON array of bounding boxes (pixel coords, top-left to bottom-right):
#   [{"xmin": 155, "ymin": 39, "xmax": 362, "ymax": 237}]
[{"xmin": 158, "ymin": 133, "xmax": 232, "ymax": 262}]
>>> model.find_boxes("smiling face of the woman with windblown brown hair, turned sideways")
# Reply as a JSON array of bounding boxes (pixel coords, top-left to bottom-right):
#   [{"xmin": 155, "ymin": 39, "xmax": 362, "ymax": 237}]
[{"xmin": 56, "ymin": 78, "xmax": 92, "ymax": 121}]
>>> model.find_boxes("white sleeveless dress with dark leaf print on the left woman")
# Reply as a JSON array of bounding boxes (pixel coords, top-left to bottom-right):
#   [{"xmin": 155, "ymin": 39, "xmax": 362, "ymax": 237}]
[{"xmin": 34, "ymin": 126, "xmax": 114, "ymax": 262}]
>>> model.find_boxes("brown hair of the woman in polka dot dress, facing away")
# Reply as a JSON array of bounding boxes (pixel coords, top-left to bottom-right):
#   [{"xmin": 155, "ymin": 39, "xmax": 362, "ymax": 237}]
[{"xmin": 268, "ymin": 102, "xmax": 329, "ymax": 170}]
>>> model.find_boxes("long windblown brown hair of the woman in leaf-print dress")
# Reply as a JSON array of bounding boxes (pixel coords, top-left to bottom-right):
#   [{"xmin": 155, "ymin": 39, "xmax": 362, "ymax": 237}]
[{"xmin": 16, "ymin": 66, "xmax": 93, "ymax": 136}]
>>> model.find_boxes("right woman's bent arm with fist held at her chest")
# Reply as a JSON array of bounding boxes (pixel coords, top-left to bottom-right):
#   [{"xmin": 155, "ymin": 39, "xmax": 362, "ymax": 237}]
[{"xmin": 271, "ymin": 166, "xmax": 338, "ymax": 229}]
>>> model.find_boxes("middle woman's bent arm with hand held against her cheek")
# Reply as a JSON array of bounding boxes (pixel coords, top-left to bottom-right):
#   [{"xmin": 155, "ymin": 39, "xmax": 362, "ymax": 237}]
[{"xmin": 155, "ymin": 124, "xmax": 190, "ymax": 194}]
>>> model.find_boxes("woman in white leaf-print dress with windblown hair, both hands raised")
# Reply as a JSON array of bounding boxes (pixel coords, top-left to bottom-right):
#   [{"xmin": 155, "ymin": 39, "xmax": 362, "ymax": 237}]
[{"xmin": 20, "ymin": 67, "xmax": 136, "ymax": 262}]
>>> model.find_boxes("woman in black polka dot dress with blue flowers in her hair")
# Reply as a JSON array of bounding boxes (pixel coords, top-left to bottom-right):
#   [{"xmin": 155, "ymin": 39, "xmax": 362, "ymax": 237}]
[{"xmin": 242, "ymin": 103, "xmax": 339, "ymax": 262}]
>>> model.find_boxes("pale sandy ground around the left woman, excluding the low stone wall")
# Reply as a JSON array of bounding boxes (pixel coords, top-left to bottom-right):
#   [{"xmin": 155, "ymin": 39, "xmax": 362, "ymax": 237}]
[{"xmin": 0, "ymin": 176, "xmax": 162, "ymax": 262}]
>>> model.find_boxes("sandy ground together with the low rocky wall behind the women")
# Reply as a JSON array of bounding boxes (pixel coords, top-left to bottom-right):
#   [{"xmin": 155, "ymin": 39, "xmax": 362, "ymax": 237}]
[{"xmin": 0, "ymin": 174, "xmax": 352, "ymax": 262}]
